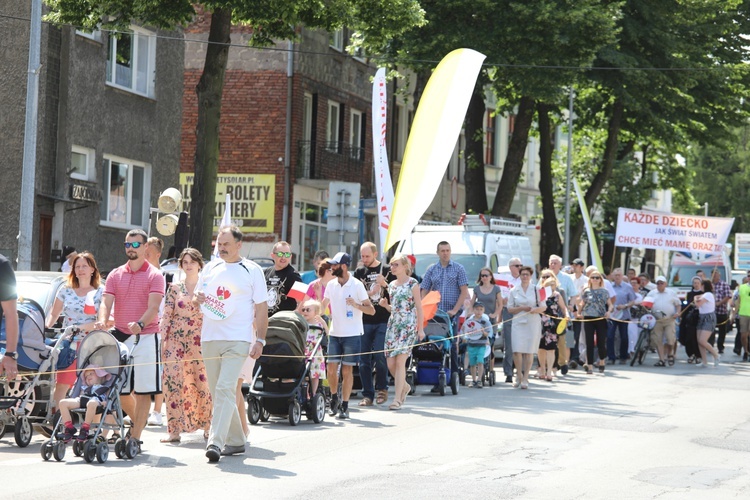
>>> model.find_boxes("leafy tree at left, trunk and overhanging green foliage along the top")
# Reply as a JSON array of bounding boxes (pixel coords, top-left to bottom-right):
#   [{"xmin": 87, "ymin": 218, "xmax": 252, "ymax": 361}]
[{"xmin": 45, "ymin": 0, "xmax": 423, "ymax": 255}]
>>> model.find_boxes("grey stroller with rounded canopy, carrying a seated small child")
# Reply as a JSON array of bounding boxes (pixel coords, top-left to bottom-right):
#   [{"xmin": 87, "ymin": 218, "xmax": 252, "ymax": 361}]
[{"xmin": 41, "ymin": 330, "xmax": 140, "ymax": 464}]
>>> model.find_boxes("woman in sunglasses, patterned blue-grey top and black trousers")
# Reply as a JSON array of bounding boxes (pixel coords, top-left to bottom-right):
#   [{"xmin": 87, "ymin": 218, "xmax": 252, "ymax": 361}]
[{"xmin": 576, "ymin": 271, "xmax": 613, "ymax": 375}]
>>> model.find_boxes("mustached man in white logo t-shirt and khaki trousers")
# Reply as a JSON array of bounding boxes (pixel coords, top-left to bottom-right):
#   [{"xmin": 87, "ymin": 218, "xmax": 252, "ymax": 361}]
[{"xmin": 193, "ymin": 226, "xmax": 268, "ymax": 462}]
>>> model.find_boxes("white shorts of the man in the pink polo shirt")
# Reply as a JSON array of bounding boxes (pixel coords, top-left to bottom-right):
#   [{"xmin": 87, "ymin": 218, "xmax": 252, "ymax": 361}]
[{"xmin": 115, "ymin": 331, "xmax": 162, "ymax": 394}]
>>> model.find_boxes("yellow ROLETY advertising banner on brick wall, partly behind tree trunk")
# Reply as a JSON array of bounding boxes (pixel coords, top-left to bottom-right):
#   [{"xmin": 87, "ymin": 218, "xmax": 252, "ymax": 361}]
[{"xmin": 180, "ymin": 173, "xmax": 276, "ymax": 233}]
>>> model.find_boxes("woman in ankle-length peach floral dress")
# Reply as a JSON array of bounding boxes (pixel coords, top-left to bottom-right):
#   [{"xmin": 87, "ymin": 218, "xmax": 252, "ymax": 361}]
[{"xmin": 161, "ymin": 248, "xmax": 212, "ymax": 443}]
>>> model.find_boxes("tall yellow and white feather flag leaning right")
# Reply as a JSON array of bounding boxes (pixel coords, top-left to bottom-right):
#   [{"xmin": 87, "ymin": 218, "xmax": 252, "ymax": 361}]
[{"xmin": 384, "ymin": 49, "xmax": 485, "ymax": 250}]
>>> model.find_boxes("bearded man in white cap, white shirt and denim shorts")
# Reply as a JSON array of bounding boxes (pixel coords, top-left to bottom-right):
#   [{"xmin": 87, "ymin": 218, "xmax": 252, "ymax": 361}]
[{"xmin": 322, "ymin": 252, "xmax": 375, "ymax": 420}]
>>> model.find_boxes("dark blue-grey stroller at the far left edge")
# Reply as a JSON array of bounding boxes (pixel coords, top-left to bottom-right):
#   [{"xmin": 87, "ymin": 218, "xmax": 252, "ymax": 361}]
[{"xmin": 0, "ymin": 299, "xmax": 78, "ymax": 448}]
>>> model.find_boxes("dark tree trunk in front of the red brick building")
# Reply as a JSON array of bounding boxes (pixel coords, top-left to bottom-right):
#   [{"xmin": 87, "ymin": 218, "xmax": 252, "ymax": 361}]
[{"xmin": 190, "ymin": 9, "xmax": 232, "ymax": 256}]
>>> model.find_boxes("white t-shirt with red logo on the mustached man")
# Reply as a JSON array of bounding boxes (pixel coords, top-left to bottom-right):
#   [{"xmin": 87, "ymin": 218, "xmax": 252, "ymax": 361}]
[{"xmin": 195, "ymin": 259, "xmax": 268, "ymax": 342}]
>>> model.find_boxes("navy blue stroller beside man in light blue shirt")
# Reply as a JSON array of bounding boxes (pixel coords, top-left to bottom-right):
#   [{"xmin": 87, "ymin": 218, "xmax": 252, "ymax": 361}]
[{"xmin": 406, "ymin": 309, "xmax": 460, "ymax": 396}]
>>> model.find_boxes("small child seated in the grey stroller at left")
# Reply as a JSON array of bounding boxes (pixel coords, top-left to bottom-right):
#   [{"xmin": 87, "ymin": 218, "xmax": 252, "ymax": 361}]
[{"xmin": 58, "ymin": 365, "xmax": 111, "ymax": 443}]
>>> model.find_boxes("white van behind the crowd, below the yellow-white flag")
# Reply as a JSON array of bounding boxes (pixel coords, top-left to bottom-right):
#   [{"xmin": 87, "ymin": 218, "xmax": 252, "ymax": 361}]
[{"xmin": 397, "ymin": 215, "xmax": 534, "ymax": 280}]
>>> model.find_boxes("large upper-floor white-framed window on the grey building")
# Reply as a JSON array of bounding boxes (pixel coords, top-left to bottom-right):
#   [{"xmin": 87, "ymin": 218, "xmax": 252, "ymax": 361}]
[{"xmin": 107, "ymin": 27, "xmax": 156, "ymax": 97}]
